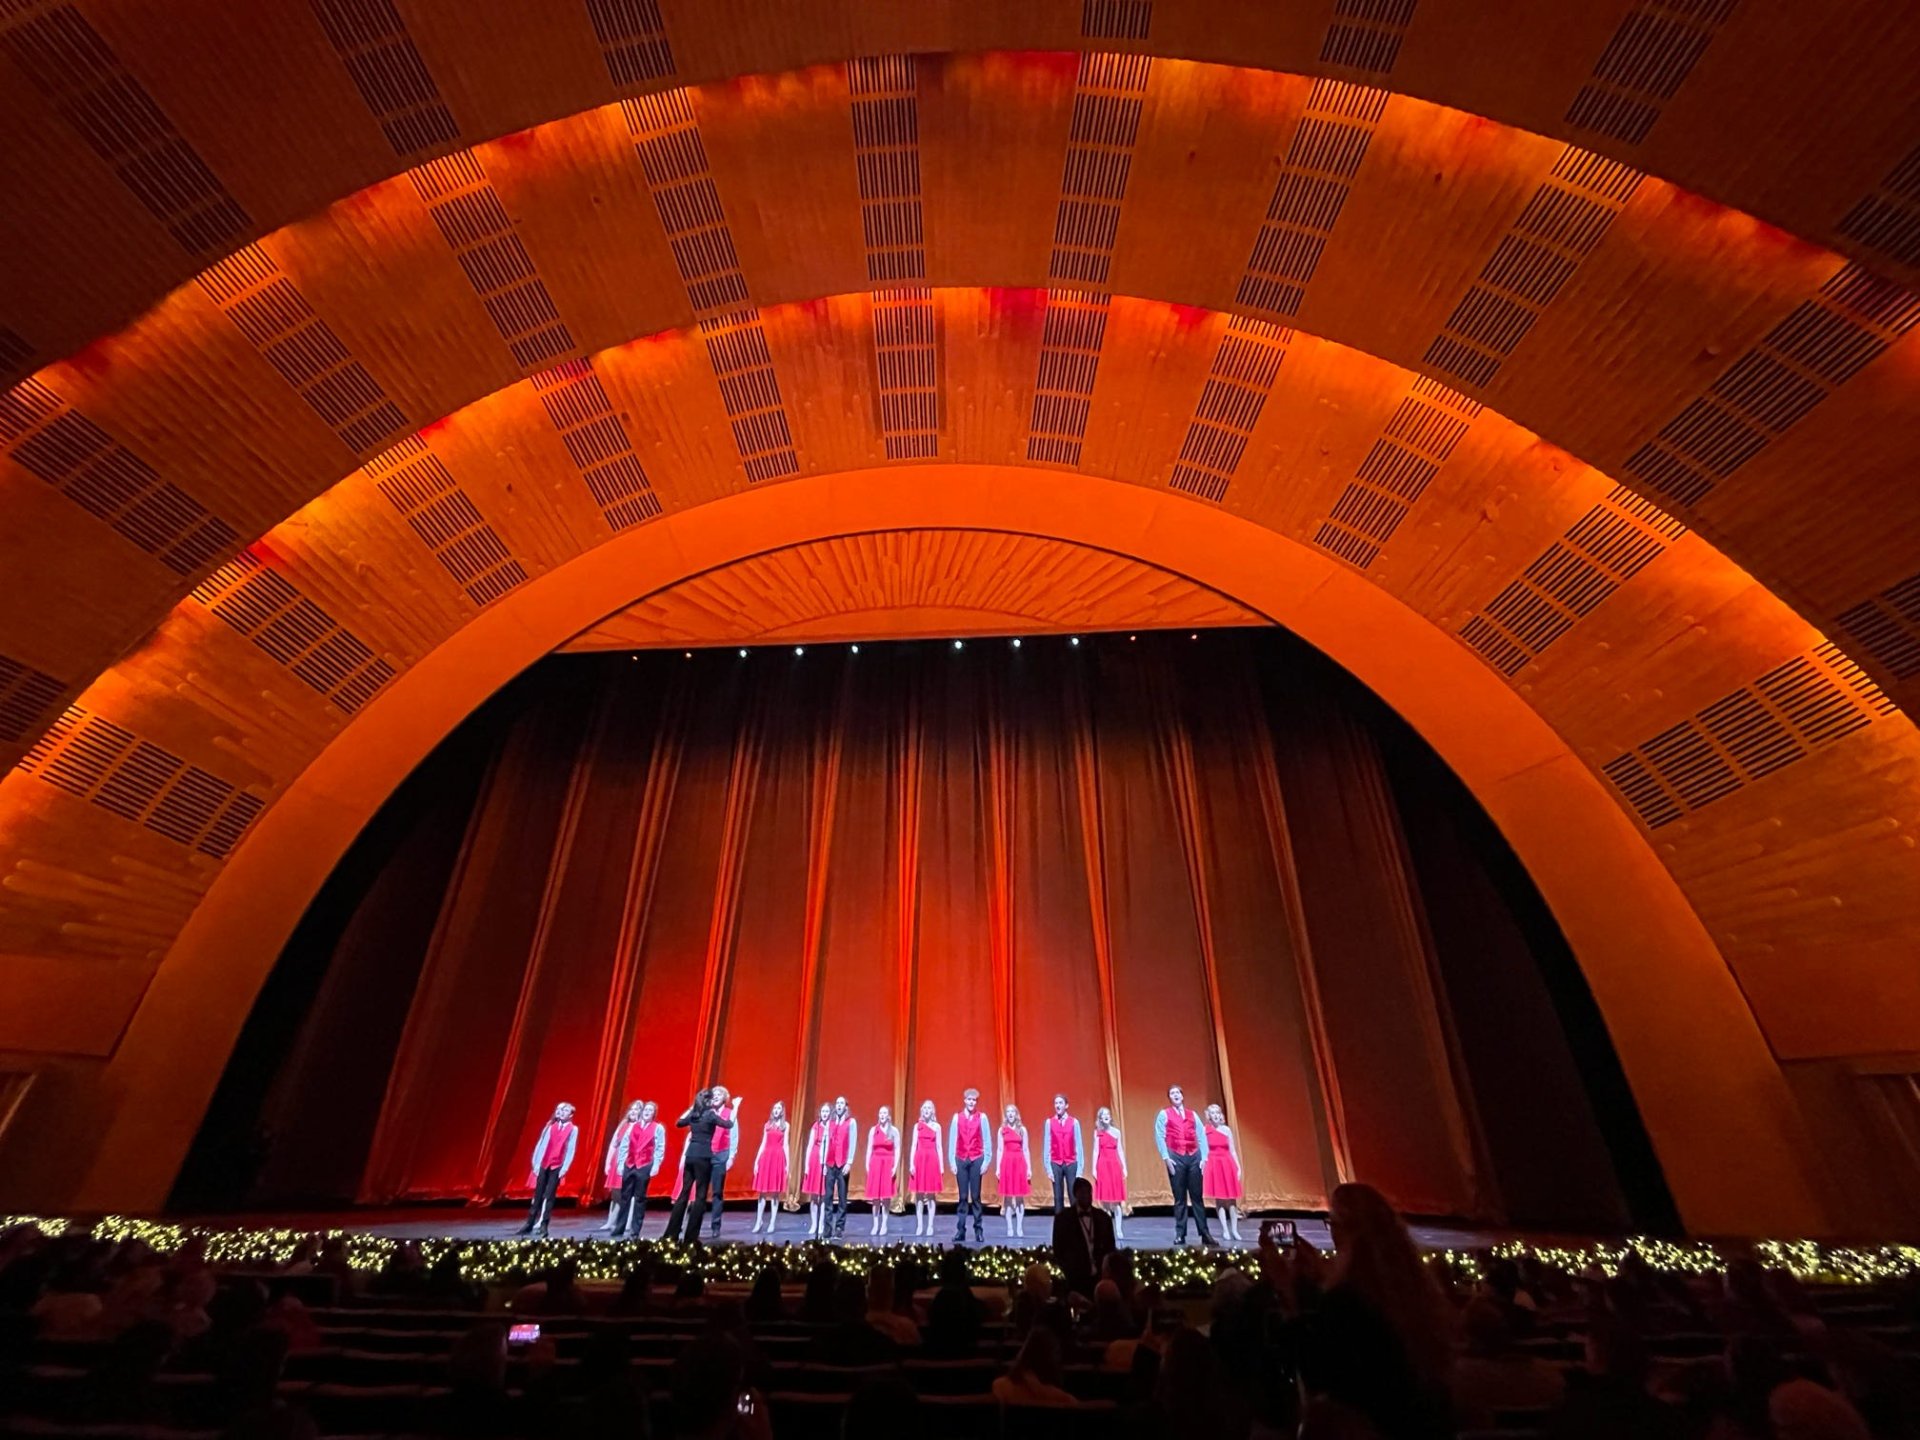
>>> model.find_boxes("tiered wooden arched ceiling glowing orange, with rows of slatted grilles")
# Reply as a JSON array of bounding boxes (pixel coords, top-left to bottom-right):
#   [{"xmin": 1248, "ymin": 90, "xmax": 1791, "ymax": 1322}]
[{"xmin": 0, "ymin": 0, "xmax": 1920, "ymax": 1228}]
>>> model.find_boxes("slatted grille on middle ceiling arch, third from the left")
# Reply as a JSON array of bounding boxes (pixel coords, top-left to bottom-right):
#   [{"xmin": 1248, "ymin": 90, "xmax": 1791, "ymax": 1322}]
[{"xmin": 198, "ymin": 246, "xmax": 407, "ymax": 455}]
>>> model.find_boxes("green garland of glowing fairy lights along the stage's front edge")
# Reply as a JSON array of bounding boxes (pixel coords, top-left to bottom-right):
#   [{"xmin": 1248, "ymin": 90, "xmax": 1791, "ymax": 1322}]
[{"xmin": 11, "ymin": 1215, "xmax": 1920, "ymax": 1292}]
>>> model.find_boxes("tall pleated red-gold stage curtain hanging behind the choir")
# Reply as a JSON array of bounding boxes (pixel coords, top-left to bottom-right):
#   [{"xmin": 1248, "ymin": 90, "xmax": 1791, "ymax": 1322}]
[{"xmin": 359, "ymin": 634, "xmax": 1486, "ymax": 1213}]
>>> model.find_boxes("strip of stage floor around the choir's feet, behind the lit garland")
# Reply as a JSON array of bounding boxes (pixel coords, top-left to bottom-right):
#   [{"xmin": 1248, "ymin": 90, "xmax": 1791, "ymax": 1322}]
[{"xmin": 188, "ymin": 1206, "xmax": 1542, "ymax": 1250}]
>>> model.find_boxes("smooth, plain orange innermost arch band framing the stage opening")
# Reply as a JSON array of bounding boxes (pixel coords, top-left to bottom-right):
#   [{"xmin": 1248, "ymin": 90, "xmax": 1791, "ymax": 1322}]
[{"xmin": 56, "ymin": 465, "xmax": 1824, "ymax": 1233}]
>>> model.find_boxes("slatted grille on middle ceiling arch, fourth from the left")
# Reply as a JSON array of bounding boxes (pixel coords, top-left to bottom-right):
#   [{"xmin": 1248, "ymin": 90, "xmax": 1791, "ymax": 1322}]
[{"xmin": 407, "ymin": 150, "xmax": 578, "ymax": 371}]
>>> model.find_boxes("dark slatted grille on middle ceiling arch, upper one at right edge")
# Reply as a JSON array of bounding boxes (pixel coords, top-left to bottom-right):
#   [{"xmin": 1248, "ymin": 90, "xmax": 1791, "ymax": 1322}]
[{"xmin": 1624, "ymin": 265, "xmax": 1920, "ymax": 505}]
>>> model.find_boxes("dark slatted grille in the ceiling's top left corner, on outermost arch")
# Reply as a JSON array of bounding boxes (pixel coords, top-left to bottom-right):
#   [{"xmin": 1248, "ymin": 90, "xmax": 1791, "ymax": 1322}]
[{"xmin": 0, "ymin": 4, "xmax": 253, "ymax": 257}]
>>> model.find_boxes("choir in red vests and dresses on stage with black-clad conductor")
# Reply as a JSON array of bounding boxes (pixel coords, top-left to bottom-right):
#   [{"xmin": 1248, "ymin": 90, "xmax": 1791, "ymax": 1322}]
[{"xmin": 518, "ymin": 1085, "xmax": 1244, "ymax": 1246}]
